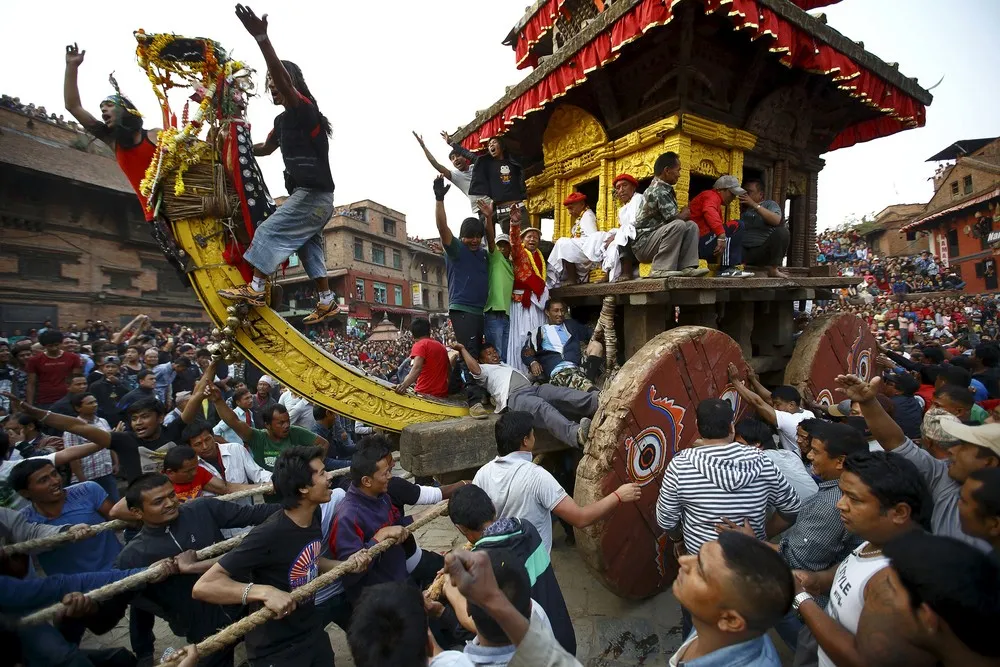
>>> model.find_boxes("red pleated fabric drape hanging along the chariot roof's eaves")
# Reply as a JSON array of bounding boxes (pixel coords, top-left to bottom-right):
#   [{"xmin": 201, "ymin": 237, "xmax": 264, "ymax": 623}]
[{"xmin": 470, "ymin": 0, "xmax": 926, "ymax": 150}]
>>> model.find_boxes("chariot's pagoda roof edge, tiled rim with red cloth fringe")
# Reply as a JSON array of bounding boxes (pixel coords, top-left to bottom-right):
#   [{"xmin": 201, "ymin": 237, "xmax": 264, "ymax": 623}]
[{"xmin": 455, "ymin": 0, "xmax": 933, "ymax": 150}]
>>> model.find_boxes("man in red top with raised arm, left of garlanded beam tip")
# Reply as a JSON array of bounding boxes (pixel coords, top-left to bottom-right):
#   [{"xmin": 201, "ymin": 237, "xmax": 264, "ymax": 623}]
[{"xmin": 63, "ymin": 44, "xmax": 160, "ymax": 222}]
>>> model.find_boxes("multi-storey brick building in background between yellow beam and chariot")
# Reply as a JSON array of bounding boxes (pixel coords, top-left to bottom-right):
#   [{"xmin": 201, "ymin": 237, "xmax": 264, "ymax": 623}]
[{"xmin": 278, "ymin": 199, "xmax": 448, "ymax": 326}]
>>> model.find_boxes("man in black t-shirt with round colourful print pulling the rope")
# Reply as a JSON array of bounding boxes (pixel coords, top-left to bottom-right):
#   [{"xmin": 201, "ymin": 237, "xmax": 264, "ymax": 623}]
[{"xmin": 192, "ymin": 447, "xmax": 371, "ymax": 667}]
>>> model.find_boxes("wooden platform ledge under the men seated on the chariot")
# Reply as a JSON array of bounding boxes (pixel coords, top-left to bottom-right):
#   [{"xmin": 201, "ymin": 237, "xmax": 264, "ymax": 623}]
[{"xmin": 551, "ymin": 276, "xmax": 858, "ymax": 306}]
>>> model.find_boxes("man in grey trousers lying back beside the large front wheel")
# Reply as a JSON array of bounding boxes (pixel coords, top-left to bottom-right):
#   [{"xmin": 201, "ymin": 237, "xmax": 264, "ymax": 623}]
[{"xmin": 452, "ymin": 343, "xmax": 598, "ymax": 448}]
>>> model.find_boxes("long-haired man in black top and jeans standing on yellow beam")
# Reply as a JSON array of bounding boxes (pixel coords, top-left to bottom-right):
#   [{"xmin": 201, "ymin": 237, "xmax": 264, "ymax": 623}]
[{"xmin": 219, "ymin": 5, "xmax": 340, "ymax": 324}]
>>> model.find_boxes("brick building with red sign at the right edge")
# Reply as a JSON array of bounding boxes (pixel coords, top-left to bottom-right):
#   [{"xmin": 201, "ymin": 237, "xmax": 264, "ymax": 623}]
[{"xmin": 902, "ymin": 137, "xmax": 1000, "ymax": 294}]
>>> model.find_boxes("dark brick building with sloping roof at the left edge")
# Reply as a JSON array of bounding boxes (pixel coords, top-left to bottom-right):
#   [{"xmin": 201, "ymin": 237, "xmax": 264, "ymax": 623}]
[{"xmin": 0, "ymin": 97, "xmax": 208, "ymax": 334}]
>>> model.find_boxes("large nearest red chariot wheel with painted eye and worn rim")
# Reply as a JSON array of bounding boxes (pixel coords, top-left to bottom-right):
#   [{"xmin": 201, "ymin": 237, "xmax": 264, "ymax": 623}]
[{"xmin": 575, "ymin": 327, "xmax": 747, "ymax": 598}]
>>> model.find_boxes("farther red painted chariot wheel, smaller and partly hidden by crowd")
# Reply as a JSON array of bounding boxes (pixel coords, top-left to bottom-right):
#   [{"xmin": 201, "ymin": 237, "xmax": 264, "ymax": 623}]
[{"xmin": 785, "ymin": 314, "xmax": 878, "ymax": 405}]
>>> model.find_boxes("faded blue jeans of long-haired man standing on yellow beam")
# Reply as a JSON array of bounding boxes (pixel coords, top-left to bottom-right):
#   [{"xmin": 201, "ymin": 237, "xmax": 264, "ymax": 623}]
[{"xmin": 243, "ymin": 188, "xmax": 333, "ymax": 279}]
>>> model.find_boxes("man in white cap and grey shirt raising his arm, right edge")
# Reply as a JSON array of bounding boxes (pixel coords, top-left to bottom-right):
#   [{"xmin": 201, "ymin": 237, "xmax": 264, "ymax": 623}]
[{"xmin": 837, "ymin": 375, "xmax": 1000, "ymax": 553}]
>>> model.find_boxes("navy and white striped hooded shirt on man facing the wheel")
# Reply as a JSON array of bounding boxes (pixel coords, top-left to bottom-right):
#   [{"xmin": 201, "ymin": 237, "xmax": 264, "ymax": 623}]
[{"xmin": 656, "ymin": 443, "xmax": 800, "ymax": 554}]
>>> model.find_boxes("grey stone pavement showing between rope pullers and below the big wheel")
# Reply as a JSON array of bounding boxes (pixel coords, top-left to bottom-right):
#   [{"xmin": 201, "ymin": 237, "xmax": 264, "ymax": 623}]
[{"xmin": 83, "ymin": 508, "xmax": 681, "ymax": 667}]
